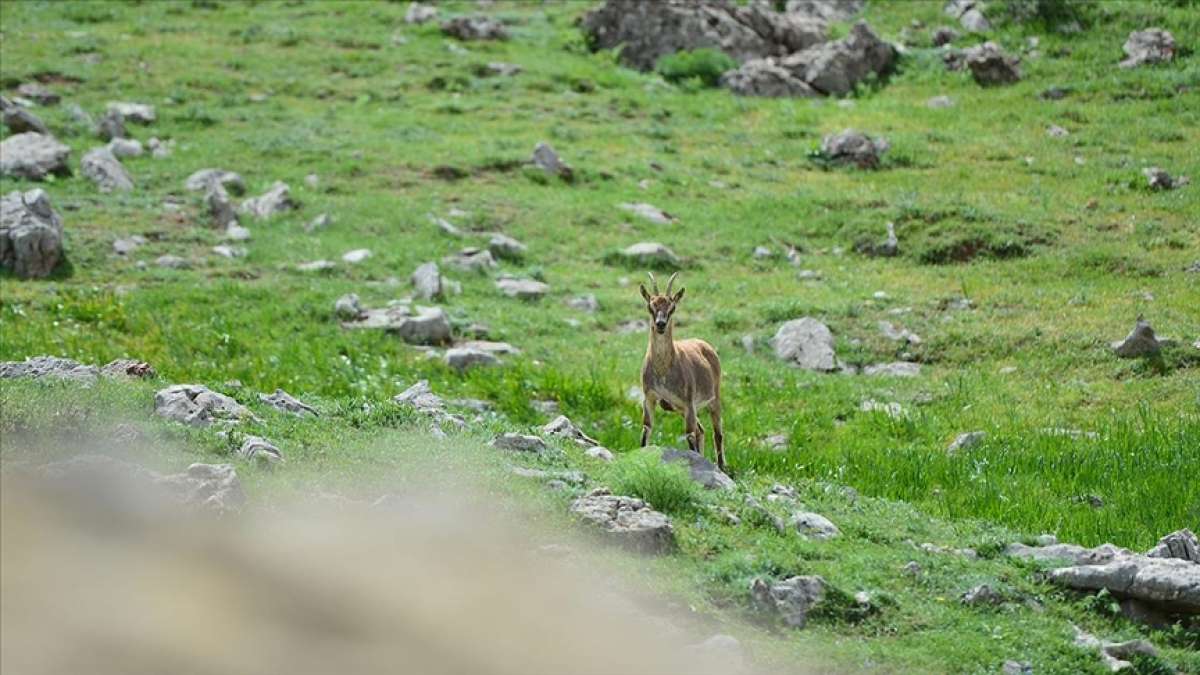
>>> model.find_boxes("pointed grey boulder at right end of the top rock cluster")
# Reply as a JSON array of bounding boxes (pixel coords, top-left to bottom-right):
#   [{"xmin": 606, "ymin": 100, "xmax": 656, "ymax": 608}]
[{"xmin": 796, "ymin": 22, "xmax": 896, "ymax": 96}]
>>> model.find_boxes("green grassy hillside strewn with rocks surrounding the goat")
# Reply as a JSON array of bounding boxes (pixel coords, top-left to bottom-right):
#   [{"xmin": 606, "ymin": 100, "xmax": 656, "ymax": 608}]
[{"xmin": 0, "ymin": 1, "xmax": 1200, "ymax": 673}]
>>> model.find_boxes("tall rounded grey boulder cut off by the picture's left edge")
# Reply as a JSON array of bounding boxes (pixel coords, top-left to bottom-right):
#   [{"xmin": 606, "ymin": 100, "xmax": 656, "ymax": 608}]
[{"xmin": 0, "ymin": 190, "xmax": 62, "ymax": 279}]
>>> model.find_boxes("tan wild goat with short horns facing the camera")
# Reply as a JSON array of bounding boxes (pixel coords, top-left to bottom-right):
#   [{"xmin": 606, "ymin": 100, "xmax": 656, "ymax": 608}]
[{"xmin": 638, "ymin": 273, "xmax": 725, "ymax": 471}]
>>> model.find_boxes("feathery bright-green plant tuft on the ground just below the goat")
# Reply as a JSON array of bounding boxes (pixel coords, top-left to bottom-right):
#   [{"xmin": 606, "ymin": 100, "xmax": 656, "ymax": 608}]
[{"xmin": 606, "ymin": 448, "xmax": 704, "ymax": 513}]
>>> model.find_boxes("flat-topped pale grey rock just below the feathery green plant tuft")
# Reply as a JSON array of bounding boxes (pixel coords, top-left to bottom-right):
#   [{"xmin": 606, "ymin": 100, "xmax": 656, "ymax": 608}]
[{"xmin": 571, "ymin": 488, "xmax": 676, "ymax": 554}]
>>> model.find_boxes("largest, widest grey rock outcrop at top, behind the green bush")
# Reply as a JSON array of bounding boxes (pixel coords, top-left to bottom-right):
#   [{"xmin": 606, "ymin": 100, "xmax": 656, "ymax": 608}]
[{"xmin": 581, "ymin": 0, "xmax": 826, "ymax": 71}]
